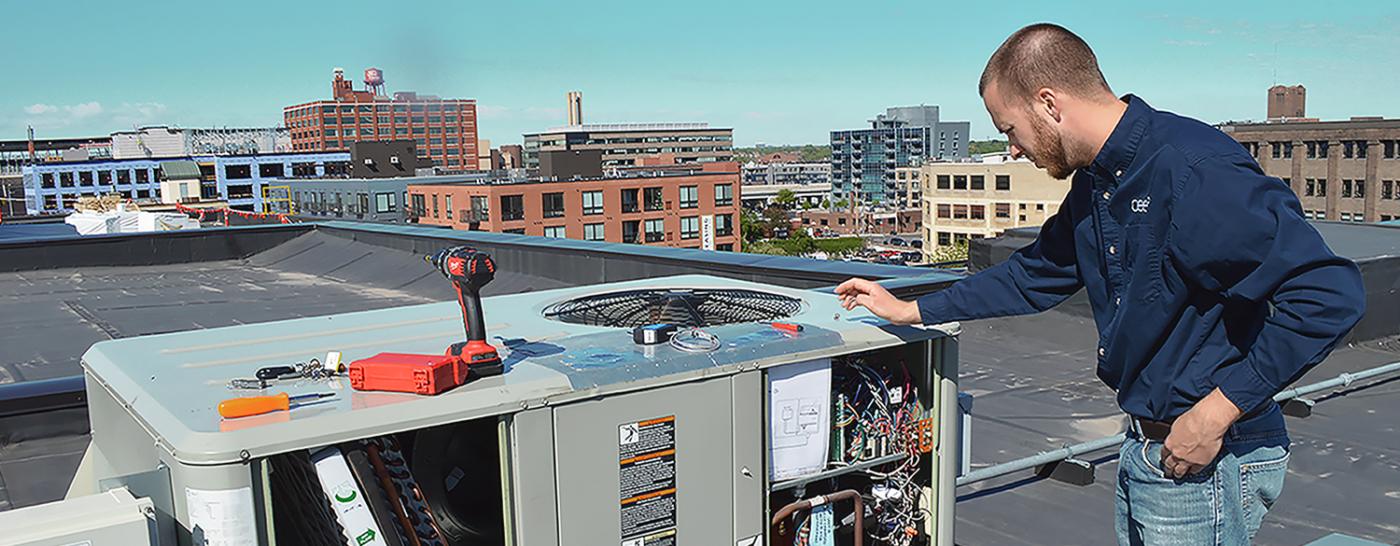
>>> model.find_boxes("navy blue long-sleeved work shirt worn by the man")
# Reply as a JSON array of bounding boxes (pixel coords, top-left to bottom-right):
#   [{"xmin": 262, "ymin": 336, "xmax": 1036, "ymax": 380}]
[{"xmin": 918, "ymin": 95, "xmax": 1365, "ymax": 440}]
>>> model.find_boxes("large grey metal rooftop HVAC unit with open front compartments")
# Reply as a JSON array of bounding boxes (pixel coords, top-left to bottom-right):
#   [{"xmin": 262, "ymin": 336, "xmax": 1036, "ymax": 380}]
[{"xmin": 70, "ymin": 276, "xmax": 956, "ymax": 546}]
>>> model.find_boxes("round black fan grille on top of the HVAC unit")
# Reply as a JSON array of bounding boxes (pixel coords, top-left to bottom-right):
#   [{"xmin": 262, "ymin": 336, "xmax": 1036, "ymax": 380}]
[{"xmin": 545, "ymin": 288, "xmax": 802, "ymax": 328}]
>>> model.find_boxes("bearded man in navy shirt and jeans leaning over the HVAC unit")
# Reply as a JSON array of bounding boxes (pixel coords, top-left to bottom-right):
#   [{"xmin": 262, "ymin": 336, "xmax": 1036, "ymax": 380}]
[{"xmin": 836, "ymin": 24, "xmax": 1364, "ymax": 545}]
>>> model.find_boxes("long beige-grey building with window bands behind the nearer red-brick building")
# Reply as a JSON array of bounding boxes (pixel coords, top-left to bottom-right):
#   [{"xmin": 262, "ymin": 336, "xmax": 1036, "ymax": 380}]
[{"xmin": 524, "ymin": 123, "xmax": 734, "ymax": 168}]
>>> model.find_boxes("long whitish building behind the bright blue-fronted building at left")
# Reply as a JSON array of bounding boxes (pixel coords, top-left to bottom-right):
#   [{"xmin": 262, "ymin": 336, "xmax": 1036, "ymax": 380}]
[{"xmin": 112, "ymin": 125, "xmax": 291, "ymax": 160}]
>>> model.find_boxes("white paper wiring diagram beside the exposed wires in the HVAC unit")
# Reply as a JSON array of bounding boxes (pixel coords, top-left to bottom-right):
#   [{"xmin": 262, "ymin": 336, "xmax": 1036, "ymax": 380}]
[{"xmin": 769, "ymin": 358, "xmax": 832, "ymax": 480}]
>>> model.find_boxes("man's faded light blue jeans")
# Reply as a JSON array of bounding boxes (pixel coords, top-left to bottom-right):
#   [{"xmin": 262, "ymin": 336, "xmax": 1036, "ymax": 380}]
[{"xmin": 1116, "ymin": 431, "xmax": 1288, "ymax": 546}]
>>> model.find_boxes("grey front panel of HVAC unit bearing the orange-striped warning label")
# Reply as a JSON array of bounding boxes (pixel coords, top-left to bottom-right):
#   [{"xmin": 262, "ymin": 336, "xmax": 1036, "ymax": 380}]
[{"xmin": 554, "ymin": 378, "xmax": 756, "ymax": 546}]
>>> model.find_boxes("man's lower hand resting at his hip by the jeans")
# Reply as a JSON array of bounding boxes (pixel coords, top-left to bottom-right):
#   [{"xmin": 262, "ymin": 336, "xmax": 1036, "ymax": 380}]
[{"xmin": 1162, "ymin": 389, "xmax": 1240, "ymax": 477}]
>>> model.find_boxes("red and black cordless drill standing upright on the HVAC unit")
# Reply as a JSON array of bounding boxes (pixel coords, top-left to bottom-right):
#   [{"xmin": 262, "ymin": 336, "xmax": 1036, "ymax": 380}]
[{"xmin": 424, "ymin": 246, "xmax": 504, "ymax": 378}]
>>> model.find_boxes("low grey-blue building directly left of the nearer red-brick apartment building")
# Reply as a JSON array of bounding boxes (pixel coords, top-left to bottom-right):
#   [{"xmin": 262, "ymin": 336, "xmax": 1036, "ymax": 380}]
[{"xmin": 272, "ymin": 171, "xmax": 501, "ymax": 224}]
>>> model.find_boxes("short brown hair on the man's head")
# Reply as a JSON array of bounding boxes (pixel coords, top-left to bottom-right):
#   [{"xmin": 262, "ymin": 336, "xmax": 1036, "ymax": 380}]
[{"xmin": 977, "ymin": 22, "xmax": 1113, "ymax": 98}]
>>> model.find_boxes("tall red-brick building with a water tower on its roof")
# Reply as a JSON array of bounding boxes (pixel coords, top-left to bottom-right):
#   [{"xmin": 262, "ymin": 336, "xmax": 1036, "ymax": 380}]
[{"xmin": 283, "ymin": 69, "xmax": 480, "ymax": 171}]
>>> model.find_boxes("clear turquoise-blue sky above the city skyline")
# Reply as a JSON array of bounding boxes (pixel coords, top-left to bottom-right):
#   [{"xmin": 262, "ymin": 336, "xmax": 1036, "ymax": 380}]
[{"xmin": 0, "ymin": 0, "xmax": 1400, "ymax": 146}]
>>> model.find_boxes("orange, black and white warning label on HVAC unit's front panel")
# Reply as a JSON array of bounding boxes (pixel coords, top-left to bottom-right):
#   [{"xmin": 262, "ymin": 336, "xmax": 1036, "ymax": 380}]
[{"xmin": 617, "ymin": 416, "xmax": 676, "ymax": 546}]
